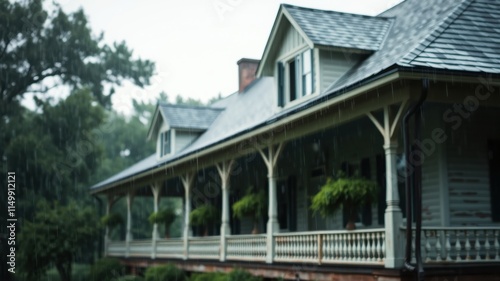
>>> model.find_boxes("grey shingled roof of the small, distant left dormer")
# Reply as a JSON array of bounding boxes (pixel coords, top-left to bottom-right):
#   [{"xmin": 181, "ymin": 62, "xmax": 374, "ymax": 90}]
[{"xmin": 160, "ymin": 104, "xmax": 223, "ymax": 130}]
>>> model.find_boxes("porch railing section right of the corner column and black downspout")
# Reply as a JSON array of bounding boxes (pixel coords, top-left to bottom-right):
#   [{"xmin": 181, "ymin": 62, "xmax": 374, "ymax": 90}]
[{"xmin": 403, "ymin": 227, "xmax": 500, "ymax": 264}]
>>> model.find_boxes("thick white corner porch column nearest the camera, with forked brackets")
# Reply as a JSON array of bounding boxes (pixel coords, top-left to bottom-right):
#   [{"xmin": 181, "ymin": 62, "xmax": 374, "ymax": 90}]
[{"xmin": 367, "ymin": 101, "xmax": 407, "ymax": 268}]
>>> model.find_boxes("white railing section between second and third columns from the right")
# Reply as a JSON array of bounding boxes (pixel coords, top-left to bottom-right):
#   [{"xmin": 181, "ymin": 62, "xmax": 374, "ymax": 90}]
[{"xmin": 226, "ymin": 234, "xmax": 267, "ymax": 261}]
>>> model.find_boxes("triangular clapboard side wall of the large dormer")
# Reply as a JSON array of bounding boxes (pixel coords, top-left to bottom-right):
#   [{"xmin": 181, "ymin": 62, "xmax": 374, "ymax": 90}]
[{"xmin": 319, "ymin": 50, "xmax": 361, "ymax": 93}]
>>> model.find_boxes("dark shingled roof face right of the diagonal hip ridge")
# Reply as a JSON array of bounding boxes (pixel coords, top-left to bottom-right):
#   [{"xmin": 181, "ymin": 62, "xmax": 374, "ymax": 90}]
[{"xmin": 399, "ymin": 0, "xmax": 500, "ymax": 73}]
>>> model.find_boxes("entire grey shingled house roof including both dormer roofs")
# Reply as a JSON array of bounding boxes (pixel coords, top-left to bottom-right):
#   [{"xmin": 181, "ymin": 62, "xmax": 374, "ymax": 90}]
[{"xmin": 92, "ymin": 0, "xmax": 500, "ymax": 190}]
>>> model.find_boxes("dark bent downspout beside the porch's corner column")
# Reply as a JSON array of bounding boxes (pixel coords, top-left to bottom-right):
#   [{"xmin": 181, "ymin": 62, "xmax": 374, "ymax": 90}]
[{"xmin": 403, "ymin": 79, "xmax": 429, "ymax": 281}]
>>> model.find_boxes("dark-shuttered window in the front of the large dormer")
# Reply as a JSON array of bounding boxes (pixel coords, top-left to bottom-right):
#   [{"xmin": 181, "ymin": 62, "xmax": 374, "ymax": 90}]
[{"xmin": 278, "ymin": 49, "xmax": 315, "ymax": 106}]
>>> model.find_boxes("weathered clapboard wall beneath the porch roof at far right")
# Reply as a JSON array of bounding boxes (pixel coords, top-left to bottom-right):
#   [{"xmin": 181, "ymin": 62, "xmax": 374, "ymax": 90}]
[{"xmin": 447, "ymin": 108, "xmax": 500, "ymax": 225}]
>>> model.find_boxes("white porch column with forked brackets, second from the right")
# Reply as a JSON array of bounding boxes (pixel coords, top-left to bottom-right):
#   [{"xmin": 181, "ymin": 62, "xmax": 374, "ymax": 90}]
[{"xmin": 257, "ymin": 142, "xmax": 283, "ymax": 263}]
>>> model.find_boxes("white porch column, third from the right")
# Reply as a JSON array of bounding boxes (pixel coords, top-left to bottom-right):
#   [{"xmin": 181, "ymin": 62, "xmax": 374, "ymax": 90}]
[{"xmin": 216, "ymin": 160, "xmax": 234, "ymax": 261}]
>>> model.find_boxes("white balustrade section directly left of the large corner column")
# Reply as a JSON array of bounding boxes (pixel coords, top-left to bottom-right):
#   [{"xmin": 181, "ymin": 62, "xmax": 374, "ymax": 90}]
[{"xmin": 274, "ymin": 228, "xmax": 385, "ymax": 264}]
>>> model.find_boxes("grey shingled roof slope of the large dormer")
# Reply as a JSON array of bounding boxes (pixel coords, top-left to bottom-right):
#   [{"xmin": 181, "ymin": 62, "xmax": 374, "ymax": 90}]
[{"xmin": 283, "ymin": 4, "xmax": 392, "ymax": 51}]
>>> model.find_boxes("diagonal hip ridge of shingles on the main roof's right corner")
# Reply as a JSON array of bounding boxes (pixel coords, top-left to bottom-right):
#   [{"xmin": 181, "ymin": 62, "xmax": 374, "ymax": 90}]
[{"xmin": 397, "ymin": 0, "xmax": 474, "ymax": 65}]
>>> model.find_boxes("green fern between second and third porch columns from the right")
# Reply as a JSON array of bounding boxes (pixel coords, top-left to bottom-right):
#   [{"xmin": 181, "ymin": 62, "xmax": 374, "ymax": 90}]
[{"xmin": 233, "ymin": 187, "xmax": 267, "ymax": 234}]
